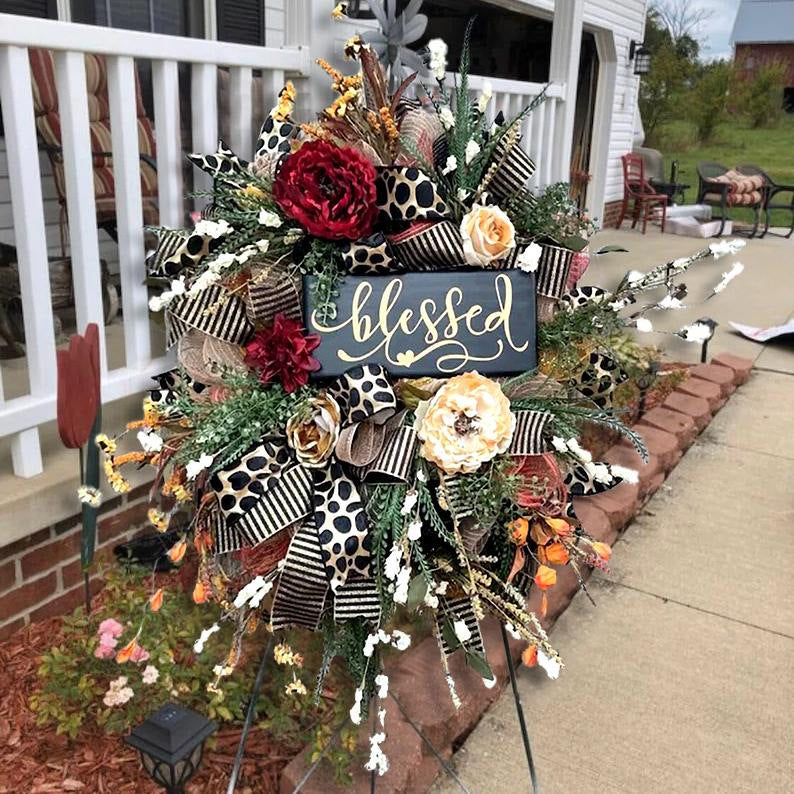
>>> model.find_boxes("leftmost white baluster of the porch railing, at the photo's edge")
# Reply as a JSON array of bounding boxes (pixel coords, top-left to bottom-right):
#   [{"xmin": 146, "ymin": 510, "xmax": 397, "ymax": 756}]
[{"xmin": 0, "ymin": 47, "xmax": 56, "ymax": 477}]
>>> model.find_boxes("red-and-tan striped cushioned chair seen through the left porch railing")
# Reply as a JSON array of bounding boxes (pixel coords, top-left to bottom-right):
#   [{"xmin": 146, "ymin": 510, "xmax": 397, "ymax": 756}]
[{"xmin": 30, "ymin": 49, "xmax": 158, "ymax": 249}]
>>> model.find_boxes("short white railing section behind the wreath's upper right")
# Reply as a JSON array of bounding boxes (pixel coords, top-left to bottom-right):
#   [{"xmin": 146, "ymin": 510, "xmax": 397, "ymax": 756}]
[{"xmin": 452, "ymin": 75, "xmax": 569, "ymax": 190}]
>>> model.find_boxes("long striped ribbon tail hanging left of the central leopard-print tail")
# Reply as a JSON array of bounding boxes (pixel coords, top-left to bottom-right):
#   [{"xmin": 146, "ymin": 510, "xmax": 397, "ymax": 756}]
[{"xmin": 270, "ymin": 521, "xmax": 329, "ymax": 631}]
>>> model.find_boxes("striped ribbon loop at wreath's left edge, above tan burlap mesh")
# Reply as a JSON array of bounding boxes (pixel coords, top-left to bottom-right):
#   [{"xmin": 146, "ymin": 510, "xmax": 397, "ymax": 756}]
[{"xmin": 166, "ymin": 284, "xmax": 254, "ymax": 347}]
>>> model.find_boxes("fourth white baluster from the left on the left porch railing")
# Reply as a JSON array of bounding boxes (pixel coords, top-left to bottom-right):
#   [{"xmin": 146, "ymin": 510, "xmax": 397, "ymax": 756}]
[{"xmin": 152, "ymin": 61, "xmax": 185, "ymax": 227}]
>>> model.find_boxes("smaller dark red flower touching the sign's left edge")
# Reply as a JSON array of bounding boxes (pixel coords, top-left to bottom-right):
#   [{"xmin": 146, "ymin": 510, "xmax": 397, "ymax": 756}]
[{"xmin": 245, "ymin": 313, "xmax": 320, "ymax": 392}]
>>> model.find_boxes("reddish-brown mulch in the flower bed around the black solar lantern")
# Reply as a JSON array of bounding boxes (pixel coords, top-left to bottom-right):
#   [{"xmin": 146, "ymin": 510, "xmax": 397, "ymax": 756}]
[{"xmin": 0, "ymin": 618, "xmax": 294, "ymax": 794}]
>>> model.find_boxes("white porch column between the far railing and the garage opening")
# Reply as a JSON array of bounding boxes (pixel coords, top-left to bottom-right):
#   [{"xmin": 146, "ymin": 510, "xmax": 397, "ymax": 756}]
[{"xmin": 549, "ymin": 0, "xmax": 584, "ymax": 182}]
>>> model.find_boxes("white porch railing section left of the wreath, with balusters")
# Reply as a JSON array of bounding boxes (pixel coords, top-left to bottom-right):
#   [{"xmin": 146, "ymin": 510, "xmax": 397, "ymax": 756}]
[{"xmin": 0, "ymin": 14, "xmax": 308, "ymax": 477}]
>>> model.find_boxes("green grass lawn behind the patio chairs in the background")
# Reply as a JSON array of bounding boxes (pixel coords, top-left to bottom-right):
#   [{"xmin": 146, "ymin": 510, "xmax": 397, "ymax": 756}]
[{"xmin": 648, "ymin": 113, "xmax": 794, "ymax": 227}]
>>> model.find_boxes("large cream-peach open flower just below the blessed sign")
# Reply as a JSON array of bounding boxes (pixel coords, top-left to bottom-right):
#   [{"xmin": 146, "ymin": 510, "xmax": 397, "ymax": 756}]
[{"xmin": 415, "ymin": 372, "xmax": 516, "ymax": 474}]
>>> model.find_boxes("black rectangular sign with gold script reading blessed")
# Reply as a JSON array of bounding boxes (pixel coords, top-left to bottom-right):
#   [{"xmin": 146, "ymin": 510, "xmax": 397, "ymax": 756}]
[{"xmin": 303, "ymin": 270, "xmax": 537, "ymax": 377}]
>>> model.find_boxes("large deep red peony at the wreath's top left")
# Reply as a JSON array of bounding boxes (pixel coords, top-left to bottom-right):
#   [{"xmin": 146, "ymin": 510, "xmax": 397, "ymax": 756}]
[{"xmin": 273, "ymin": 141, "xmax": 378, "ymax": 240}]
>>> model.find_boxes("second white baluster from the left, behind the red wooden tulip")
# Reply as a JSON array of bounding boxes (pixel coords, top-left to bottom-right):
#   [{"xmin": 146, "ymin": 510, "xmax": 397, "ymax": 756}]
[{"xmin": 55, "ymin": 52, "xmax": 107, "ymax": 374}]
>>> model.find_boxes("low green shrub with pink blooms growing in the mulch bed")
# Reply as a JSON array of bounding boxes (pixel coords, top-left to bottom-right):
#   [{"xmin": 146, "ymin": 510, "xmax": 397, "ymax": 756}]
[{"xmin": 30, "ymin": 567, "xmax": 355, "ymax": 781}]
